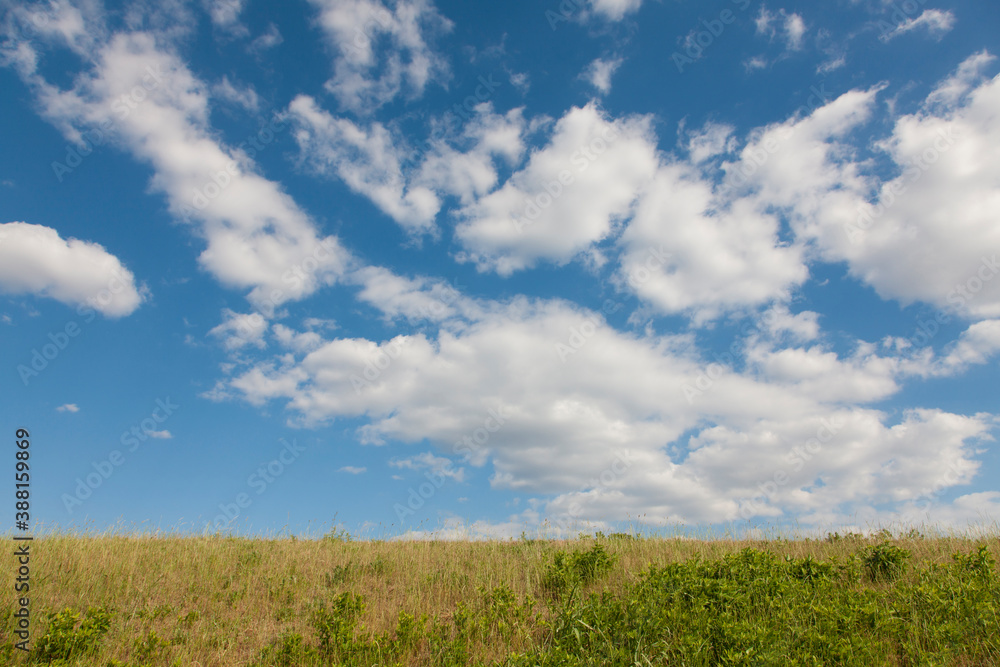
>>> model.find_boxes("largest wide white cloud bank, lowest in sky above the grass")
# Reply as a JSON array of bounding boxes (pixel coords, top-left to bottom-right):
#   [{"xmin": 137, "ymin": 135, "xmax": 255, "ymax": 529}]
[{"xmin": 207, "ymin": 264, "xmax": 996, "ymax": 525}]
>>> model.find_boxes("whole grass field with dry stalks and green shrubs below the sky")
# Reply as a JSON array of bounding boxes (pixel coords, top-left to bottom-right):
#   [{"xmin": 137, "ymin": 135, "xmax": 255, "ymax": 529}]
[{"xmin": 0, "ymin": 533, "xmax": 1000, "ymax": 667}]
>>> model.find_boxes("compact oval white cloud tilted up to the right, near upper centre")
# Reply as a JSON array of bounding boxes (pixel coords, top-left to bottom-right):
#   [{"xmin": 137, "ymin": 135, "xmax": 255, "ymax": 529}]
[{"xmin": 455, "ymin": 104, "xmax": 658, "ymax": 275}]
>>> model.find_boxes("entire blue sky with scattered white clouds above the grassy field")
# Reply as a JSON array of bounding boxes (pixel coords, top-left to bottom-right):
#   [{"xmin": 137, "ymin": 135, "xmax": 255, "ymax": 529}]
[{"xmin": 0, "ymin": 0, "xmax": 1000, "ymax": 537}]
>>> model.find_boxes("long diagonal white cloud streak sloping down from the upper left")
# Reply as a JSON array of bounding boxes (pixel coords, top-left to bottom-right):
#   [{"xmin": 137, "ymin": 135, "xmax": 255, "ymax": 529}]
[{"xmin": 2, "ymin": 20, "xmax": 350, "ymax": 309}]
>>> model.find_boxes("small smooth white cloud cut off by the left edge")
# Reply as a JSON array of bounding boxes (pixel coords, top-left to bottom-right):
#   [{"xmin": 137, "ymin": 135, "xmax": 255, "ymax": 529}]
[{"xmin": 0, "ymin": 222, "xmax": 145, "ymax": 317}]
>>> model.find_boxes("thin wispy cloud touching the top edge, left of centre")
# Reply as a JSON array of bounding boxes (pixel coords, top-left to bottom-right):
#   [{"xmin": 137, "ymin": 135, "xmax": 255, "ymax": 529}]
[{"xmin": 310, "ymin": 0, "xmax": 452, "ymax": 113}]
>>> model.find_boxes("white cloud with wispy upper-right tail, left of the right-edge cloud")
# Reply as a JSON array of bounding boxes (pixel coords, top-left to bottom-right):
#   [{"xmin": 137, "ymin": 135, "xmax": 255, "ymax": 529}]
[{"xmin": 618, "ymin": 91, "xmax": 875, "ymax": 323}]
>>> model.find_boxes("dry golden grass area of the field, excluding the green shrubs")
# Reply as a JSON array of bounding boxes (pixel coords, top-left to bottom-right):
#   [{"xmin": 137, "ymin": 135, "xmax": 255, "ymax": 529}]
[{"xmin": 2, "ymin": 532, "xmax": 1000, "ymax": 667}]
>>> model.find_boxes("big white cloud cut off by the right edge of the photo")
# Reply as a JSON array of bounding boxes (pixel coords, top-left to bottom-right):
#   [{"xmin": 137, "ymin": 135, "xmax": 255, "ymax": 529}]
[{"xmin": 808, "ymin": 54, "xmax": 1000, "ymax": 318}]
